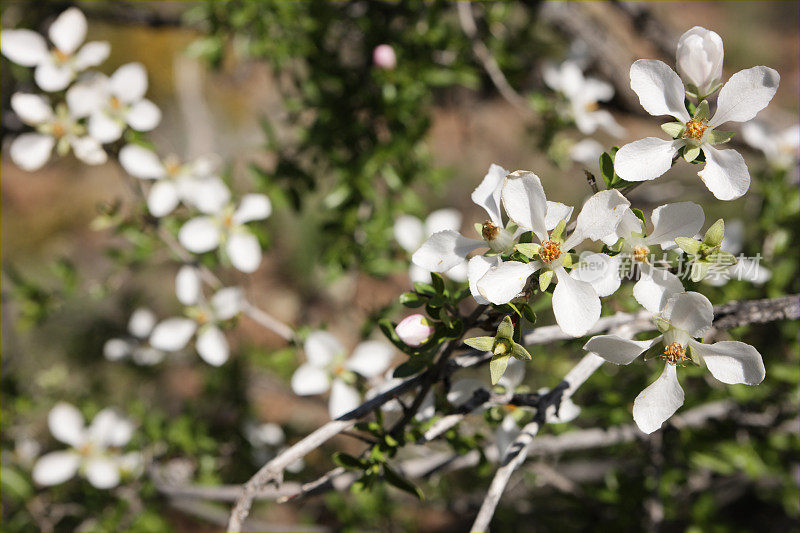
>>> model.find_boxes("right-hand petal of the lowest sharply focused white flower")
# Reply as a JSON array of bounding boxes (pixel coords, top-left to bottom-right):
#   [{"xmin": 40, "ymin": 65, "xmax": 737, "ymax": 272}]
[{"xmin": 689, "ymin": 340, "xmax": 767, "ymax": 385}]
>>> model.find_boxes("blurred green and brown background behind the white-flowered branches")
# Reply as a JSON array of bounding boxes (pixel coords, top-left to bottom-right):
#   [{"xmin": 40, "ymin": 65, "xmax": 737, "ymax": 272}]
[{"xmin": 0, "ymin": 0, "xmax": 800, "ymax": 532}]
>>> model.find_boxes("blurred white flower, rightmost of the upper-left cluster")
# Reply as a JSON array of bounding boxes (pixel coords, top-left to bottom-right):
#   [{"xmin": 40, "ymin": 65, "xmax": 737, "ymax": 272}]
[{"xmin": 67, "ymin": 63, "xmax": 161, "ymax": 144}]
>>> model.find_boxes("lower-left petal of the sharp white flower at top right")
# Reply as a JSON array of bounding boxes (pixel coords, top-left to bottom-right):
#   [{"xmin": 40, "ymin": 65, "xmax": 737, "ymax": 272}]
[{"xmin": 614, "ymin": 137, "xmax": 685, "ymax": 181}]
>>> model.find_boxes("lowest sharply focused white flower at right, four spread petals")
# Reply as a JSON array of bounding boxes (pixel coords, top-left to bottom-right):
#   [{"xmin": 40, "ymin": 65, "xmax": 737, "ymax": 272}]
[{"xmin": 584, "ymin": 292, "xmax": 766, "ymax": 433}]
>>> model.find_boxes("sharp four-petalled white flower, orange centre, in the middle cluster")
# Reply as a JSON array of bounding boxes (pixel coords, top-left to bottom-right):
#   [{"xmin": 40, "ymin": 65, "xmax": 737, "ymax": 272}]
[{"xmin": 473, "ymin": 171, "xmax": 630, "ymax": 337}]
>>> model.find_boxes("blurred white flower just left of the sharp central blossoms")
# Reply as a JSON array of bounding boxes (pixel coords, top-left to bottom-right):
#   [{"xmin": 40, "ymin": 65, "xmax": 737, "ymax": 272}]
[{"xmin": 394, "ymin": 209, "xmax": 467, "ymax": 283}]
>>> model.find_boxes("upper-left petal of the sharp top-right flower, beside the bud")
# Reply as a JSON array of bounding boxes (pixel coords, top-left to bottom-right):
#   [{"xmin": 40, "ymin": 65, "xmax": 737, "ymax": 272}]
[{"xmin": 618, "ymin": 59, "xmax": 691, "ymax": 122}]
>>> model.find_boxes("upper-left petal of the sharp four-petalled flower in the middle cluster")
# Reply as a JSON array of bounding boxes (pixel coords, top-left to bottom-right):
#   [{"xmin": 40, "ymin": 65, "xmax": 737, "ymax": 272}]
[{"xmin": 502, "ymin": 171, "xmax": 547, "ymax": 241}]
